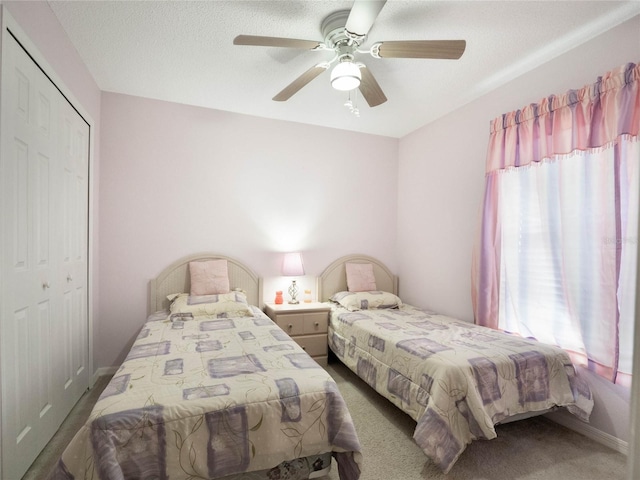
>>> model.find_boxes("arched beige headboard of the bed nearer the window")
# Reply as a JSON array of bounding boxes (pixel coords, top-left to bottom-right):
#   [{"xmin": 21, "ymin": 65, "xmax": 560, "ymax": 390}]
[{"xmin": 318, "ymin": 254, "xmax": 398, "ymax": 302}]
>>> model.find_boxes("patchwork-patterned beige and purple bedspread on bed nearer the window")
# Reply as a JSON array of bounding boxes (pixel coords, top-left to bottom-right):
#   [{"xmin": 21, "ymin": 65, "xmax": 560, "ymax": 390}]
[{"xmin": 329, "ymin": 304, "xmax": 593, "ymax": 473}]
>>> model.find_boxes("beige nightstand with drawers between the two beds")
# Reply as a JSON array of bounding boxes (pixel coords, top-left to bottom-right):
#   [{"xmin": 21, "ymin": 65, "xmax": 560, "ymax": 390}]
[{"xmin": 265, "ymin": 302, "xmax": 331, "ymax": 367}]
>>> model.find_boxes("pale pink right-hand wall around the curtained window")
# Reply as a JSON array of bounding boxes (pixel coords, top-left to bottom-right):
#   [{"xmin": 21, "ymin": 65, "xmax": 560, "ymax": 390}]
[{"xmin": 397, "ymin": 16, "xmax": 640, "ymax": 441}]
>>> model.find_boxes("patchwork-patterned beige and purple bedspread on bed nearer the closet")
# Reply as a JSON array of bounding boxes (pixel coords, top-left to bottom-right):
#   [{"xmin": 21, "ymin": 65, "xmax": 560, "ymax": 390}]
[{"xmin": 50, "ymin": 307, "xmax": 361, "ymax": 480}]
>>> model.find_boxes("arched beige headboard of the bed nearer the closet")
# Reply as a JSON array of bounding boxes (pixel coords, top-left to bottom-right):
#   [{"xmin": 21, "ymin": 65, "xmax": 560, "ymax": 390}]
[{"xmin": 148, "ymin": 253, "xmax": 262, "ymax": 314}]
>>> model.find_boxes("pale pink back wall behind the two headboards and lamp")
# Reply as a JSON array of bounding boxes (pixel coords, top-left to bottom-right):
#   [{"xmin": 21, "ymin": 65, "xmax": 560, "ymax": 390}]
[{"xmin": 99, "ymin": 93, "xmax": 398, "ymax": 366}]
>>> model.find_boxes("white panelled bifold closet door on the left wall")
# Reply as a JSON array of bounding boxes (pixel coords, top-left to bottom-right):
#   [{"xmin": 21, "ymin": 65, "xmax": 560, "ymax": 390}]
[{"xmin": 0, "ymin": 31, "xmax": 88, "ymax": 479}]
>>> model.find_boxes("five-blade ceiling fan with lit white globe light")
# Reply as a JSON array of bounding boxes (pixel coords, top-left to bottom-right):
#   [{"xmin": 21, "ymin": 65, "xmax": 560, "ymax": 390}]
[{"xmin": 233, "ymin": 0, "xmax": 466, "ymax": 107}]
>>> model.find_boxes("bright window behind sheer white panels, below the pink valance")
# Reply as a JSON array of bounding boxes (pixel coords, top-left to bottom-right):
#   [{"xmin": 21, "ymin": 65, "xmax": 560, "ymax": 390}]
[{"xmin": 498, "ymin": 141, "xmax": 640, "ymax": 380}]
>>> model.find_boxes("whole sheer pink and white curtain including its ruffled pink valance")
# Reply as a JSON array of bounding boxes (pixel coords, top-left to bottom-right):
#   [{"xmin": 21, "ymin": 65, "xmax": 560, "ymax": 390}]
[{"xmin": 473, "ymin": 64, "xmax": 640, "ymax": 384}]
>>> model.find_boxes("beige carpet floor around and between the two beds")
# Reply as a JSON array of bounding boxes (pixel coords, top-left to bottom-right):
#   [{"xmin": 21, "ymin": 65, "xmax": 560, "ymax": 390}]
[{"xmin": 21, "ymin": 361, "xmax": 626, "ymax": 480}]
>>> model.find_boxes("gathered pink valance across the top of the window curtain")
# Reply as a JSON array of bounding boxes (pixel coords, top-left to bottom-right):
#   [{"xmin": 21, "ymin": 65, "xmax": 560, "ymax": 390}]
[{"xmin": 487, "ymin": 63, "xmax": 640, "ymax": 173}]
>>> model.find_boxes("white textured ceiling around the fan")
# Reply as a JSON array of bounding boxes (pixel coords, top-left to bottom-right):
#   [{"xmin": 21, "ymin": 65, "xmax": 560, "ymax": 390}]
[{"xmin": 49, "ymin": 0, "xmax": 640, "ymax": 138}]
